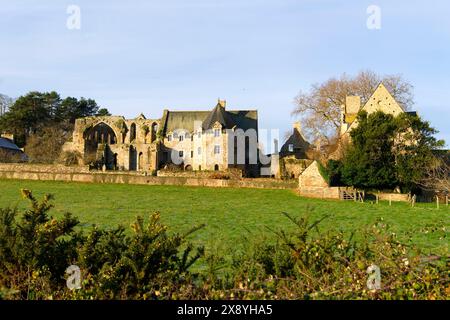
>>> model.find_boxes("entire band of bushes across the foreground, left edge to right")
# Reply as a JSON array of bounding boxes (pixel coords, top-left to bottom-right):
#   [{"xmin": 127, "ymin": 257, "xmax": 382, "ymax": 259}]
[{"xmin": 0, "ymin": 190, "xmax": 450, "ymax": 299}]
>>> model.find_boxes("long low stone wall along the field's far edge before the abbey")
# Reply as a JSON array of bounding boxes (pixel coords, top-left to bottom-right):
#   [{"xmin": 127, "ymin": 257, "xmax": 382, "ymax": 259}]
[{"xmin": 0, "ymin": 170, "xmax": 297, "ymax": 189}]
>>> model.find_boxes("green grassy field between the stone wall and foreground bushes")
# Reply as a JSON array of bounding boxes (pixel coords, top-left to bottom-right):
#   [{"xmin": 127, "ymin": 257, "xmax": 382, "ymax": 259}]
[{"xmin": 0, "ymin": 180, "xmax": 450, "ymax": 254}]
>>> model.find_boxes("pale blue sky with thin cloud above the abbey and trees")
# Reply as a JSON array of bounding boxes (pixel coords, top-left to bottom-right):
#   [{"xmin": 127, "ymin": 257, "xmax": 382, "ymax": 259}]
[{"xmin": 0, "ymin": 0, "xmax": 450, "ymax": 146}]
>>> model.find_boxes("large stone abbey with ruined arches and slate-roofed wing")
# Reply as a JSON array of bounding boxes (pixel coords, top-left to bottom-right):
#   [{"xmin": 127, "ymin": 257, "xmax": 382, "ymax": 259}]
[{"xmin": 63, "ymin": 100, "xmax": 259, "ymax": 176}]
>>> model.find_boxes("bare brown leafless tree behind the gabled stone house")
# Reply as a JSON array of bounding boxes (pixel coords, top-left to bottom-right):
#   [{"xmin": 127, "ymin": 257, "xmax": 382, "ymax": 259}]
[{"xmin": 292, "ymin": 71, "xmax": 414, "ymax": 143}]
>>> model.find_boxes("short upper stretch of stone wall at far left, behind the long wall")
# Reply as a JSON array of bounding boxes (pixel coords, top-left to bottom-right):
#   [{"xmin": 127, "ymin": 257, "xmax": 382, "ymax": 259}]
[{"xmin": 0, "ymin": 163, "xmax": 89, "ymax": 173}]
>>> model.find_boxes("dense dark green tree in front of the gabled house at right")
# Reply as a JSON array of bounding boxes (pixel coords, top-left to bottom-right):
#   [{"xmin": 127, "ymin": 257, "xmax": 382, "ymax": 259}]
[{"xmin": 336, "ymin": 111, "xmax": 444, "ymax": 191}]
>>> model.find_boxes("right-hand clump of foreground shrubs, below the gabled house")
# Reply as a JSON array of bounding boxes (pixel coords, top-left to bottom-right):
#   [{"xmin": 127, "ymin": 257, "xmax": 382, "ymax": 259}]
[{"xmin": 223, "ymin": 214, "xmax": 449, "ymax": 299}]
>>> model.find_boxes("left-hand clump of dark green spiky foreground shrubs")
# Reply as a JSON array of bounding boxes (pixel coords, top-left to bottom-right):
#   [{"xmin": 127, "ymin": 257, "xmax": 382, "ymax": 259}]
[{"xmin": 0, "ymin": 190, "xmax": 203, "ymax": 299}]
